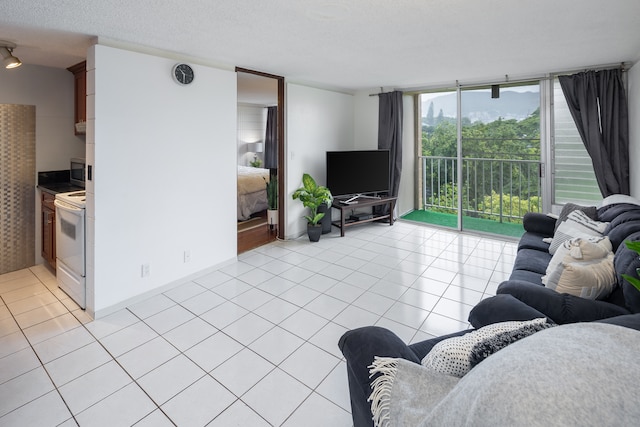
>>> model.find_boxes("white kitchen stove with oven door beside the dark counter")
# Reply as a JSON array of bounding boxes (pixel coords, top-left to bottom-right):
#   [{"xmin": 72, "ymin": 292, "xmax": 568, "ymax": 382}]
[{"xmin": 54, "ymin": 191, "xmax": 87, "ymax": 308}]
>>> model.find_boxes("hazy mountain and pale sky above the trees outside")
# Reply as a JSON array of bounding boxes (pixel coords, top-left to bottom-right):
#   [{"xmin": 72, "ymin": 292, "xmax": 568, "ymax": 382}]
[{"xmin": 422, "ymin": 89, "xmax": 540, "ymax": 123}]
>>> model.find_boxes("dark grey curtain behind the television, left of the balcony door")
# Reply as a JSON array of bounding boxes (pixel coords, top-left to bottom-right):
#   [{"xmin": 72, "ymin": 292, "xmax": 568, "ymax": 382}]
[{"xmin": 378, "ymin": 91, "xmax": 402, "ymax": 217}]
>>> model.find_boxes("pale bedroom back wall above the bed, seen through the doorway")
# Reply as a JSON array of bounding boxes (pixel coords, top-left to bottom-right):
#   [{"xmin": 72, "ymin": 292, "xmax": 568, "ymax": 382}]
[{"xmin": 237, "ymin": 105, "xmax": 267, "ymax": 166}]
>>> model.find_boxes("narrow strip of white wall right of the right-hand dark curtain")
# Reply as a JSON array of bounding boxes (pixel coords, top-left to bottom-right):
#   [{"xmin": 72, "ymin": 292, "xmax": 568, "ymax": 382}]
[{"xmin": 627, "ymin": 62, "xmax": 640, "ymax": 198}]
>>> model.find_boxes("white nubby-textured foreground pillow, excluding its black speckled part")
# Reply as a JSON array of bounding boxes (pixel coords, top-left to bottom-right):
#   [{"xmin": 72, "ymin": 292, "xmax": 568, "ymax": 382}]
[{"xmin": 421, "ymin": 317, "xmax": 547, "ymax": 377}]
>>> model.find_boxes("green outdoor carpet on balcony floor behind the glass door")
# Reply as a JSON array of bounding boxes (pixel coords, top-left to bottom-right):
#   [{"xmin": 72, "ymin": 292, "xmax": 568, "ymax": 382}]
[{"xmin": 402, "ymin": 210, "xmax": 524, "ymax": 237}]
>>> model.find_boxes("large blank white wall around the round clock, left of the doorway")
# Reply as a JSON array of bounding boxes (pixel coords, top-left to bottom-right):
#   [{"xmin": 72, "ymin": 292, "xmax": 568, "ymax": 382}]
[{"xmin": 87, "ymin": 45, "xmax": 237, "ymax": 317}]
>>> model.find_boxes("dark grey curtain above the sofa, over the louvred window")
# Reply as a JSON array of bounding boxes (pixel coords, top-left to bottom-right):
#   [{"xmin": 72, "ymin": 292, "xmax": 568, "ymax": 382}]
[{"xmin": 558, "ymin": 69, "xmax": 629, "ymax": 197}]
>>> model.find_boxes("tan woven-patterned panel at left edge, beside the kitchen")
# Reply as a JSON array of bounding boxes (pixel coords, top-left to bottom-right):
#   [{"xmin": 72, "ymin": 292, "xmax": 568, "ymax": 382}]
[{"xmin": 0, "ymin": 104, "xmax": 36, "ymax": 274}]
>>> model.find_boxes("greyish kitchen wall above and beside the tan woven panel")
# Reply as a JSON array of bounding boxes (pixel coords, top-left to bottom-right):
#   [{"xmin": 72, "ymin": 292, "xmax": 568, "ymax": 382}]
[{"xmin": 0, "ymin": 65, "xmax": 85, "ymax": 264}]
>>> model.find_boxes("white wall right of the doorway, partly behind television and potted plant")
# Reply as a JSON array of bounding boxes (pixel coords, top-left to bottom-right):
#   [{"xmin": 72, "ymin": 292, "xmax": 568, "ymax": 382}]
[{"xmin": 285, "ymin": 83, "xmax": 355, "ymax": 239}]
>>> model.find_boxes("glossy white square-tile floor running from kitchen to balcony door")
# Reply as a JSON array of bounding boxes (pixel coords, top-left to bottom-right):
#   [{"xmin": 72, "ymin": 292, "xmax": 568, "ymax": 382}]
[{"xmin": 0, "ymin": 221, "xmax": 516, "ymax": 427}]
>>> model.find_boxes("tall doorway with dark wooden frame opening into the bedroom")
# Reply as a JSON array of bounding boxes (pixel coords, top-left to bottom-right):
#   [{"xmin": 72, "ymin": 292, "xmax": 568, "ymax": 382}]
[{"xmin": 236, "ymin": 68, "xmax": 285, "ymax": 253}]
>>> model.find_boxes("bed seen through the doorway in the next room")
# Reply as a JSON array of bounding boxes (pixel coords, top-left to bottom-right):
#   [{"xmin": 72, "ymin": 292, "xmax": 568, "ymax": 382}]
[{"xmin": 238, "ymin": 165, "xmax": 269, "ymax": 221}]
